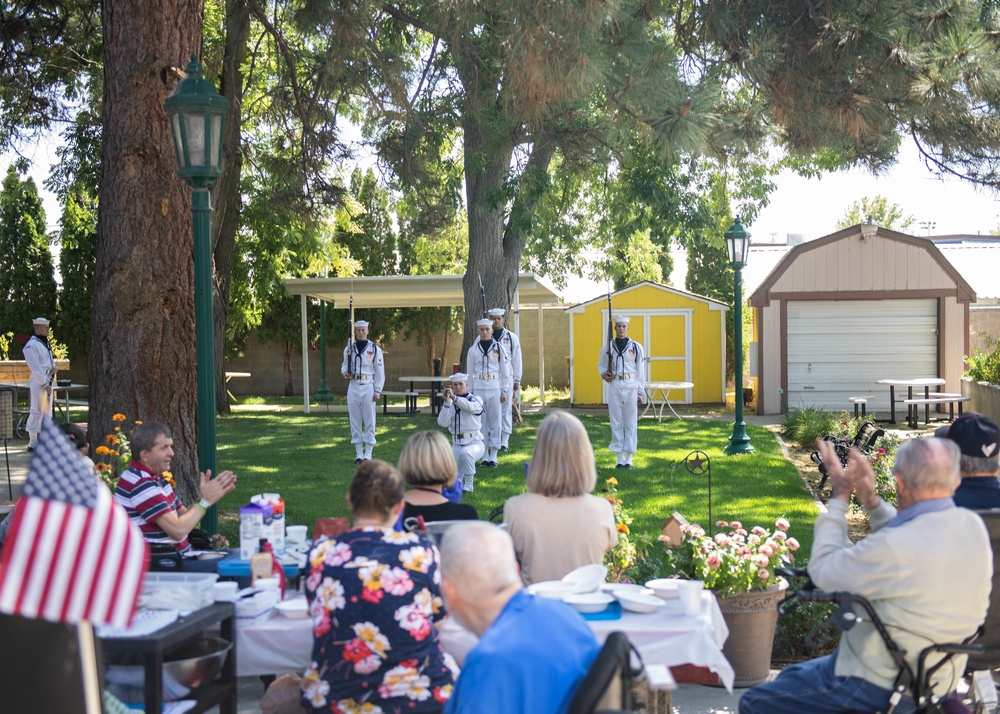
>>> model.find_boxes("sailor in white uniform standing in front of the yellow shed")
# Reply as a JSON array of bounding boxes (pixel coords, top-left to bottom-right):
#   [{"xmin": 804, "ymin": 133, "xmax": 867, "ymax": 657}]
[{"xmin": 598, "ymin": 317, "xmax": 645, "ymax": 469}]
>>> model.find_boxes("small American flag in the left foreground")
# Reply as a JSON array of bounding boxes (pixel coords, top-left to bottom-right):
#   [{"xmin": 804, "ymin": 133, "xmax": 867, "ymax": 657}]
[{"xmin": 0, "ymin": 417, "xmax": 147, "ymax": 626}]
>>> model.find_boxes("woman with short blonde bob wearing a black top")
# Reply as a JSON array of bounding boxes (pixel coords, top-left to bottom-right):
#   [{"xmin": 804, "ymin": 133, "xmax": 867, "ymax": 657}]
[{"xmin": 399, "ymin": 431, "xmax": 479, "ymax": 521}]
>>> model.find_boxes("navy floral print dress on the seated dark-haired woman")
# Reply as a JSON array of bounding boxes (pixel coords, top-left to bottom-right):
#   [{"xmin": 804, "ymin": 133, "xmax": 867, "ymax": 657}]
[{"xmin": 302, "ymin": 527, "xmax": 457, "ymax": 714}]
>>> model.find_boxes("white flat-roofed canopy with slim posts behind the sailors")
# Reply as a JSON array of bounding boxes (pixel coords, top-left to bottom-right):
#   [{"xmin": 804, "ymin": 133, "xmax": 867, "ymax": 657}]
[{"xmin": 283, "ymin": 273, "xmax": 561, "ymax": 414}]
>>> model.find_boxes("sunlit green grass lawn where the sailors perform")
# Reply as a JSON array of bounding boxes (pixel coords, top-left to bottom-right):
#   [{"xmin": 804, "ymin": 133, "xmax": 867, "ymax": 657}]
[{"xmin": 218, "ymin": 408, "xmax": 817, "ymax": 556}]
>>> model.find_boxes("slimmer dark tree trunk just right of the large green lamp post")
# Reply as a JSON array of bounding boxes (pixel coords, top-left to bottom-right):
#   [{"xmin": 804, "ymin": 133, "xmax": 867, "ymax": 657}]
[{"xmin": 212, "ymin": 0, "xmax": 250, "ymax": 414}]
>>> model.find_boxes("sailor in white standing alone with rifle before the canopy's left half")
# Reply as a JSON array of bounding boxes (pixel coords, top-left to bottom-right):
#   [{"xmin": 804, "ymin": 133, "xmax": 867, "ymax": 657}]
[{"xmin": 340, "ymin": 320, "xmax": 385, "ymax": 464}]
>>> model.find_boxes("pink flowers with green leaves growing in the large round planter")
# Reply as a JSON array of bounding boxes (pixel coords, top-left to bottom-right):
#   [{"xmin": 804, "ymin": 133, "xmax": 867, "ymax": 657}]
[{"xmin": 660, "ymin": 518, "xmax": 799, "ymax": 597}]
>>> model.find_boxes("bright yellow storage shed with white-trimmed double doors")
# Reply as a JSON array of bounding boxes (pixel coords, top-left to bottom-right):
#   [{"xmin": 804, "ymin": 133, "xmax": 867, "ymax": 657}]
[{"xmin": 566, "ymin": 281, "xmax": 729, "ymax": 406}]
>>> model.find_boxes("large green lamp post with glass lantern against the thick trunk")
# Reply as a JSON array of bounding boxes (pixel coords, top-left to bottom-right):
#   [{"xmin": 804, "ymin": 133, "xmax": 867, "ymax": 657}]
[{"xmin": 163, "ymin": 55, "xmax": 228, "ymax": 534}]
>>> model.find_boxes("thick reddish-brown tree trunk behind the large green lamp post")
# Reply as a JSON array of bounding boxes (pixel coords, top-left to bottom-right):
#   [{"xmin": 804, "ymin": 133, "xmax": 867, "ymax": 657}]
[{"xmin": 97, "ymin": 0, "xmax": 203, "ymax": 503}]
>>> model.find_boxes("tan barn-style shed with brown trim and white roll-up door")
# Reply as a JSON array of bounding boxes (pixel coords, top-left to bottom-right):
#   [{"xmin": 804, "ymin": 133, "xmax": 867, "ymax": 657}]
[{"xmin": 749, "ymin": 225, "xmax": 976, "ymax": 414}]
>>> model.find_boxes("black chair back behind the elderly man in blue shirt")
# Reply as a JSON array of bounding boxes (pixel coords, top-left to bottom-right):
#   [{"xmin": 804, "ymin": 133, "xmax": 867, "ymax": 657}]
[{"xmin": 569, "ymin": 632, "xmax": 642, "ymax": 714}]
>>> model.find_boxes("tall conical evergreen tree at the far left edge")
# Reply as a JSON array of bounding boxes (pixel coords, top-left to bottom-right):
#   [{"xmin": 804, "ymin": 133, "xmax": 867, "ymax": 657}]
[{"xmin": 0, "ymin": 161, "xmax": 56, "ymax": 335}]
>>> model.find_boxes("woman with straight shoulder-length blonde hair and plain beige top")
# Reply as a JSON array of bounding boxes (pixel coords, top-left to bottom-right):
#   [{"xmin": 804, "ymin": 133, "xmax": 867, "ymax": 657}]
[{"xmin": 503, "ymin": 411, "xmax": 618, "ymax": 584}]
